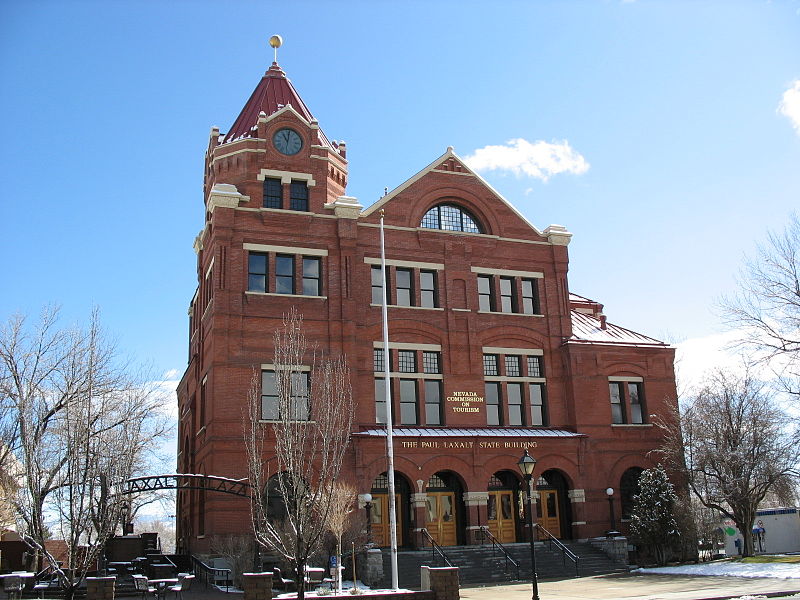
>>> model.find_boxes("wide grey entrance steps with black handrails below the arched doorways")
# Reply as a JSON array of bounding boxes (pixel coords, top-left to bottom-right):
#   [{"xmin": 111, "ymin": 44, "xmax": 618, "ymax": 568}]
[{"xmin": 381, "ymin": 540, "xmax": 626, "ymax": 589}]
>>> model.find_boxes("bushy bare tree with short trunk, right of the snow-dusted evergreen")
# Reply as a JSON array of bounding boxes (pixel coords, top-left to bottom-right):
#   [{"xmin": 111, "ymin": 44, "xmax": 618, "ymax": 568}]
[{"xmin": 659, "ymin": 367, "xmax": 800, "ymax": 556}]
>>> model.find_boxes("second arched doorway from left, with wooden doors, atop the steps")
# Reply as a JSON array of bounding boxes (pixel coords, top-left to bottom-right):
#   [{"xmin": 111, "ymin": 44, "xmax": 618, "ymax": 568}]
[{"xmin": 425, "ymin": 471, "xmax": 466, "ymax": 546}]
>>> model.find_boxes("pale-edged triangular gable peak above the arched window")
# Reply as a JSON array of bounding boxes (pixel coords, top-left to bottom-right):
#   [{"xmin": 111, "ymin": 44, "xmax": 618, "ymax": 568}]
[{"xmin": 362, "ymin": 146, "xmax": 571, "ymax": 245}]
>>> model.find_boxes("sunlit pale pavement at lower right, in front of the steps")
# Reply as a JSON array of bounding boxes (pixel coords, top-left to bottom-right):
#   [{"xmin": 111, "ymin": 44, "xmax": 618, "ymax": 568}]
[{"xmin": 461, "ymin": 573, "xmax": 800, "ymax": 600}]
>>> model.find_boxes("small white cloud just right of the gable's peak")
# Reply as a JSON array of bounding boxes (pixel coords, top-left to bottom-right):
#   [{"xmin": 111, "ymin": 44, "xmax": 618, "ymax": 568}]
[{"xmin": 464, "ymin": 138, "xmax": 589, "ymax": 181}]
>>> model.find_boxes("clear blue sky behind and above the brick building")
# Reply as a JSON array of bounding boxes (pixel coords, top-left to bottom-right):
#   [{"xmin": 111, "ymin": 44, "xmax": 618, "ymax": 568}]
[{"xmin": 0, "ymin": 0, "xmax": 800, "ymax": 394}]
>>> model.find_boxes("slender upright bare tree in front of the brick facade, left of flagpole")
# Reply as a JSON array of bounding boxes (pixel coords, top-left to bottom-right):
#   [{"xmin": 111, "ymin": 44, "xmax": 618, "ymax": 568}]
[{"xmin": 245, "ymin": 309, "xmax": 353, "ymax": 598}]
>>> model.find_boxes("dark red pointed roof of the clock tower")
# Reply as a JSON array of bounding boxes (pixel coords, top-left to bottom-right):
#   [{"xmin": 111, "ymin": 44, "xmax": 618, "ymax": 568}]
[{"xmin": 222, "ymin": 62, "xmax": 335, "ymax": 149}]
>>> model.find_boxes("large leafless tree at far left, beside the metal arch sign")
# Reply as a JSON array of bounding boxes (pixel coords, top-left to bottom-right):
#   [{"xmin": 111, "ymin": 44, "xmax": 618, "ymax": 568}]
[{"xmin": 0, "ymin": 309, "xmax": 167, "ymax": 598}]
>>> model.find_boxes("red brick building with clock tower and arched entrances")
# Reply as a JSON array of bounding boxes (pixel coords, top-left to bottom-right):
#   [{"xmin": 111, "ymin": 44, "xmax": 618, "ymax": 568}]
[{"xmin": 178, "ymin": 57, "xmax": 676, "ymax": 551}]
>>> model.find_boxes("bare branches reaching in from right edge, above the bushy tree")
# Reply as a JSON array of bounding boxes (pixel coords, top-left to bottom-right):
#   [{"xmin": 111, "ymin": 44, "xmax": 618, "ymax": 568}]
[{"xmin": 722, "ymin": 214, "xmax": 800, "ymax": 396}]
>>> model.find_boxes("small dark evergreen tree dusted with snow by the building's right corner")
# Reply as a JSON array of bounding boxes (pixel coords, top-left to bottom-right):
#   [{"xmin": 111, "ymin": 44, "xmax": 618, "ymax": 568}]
[{"xmin": 631, "ymin": 465, "xmax": 679, "ymax": 565}]
